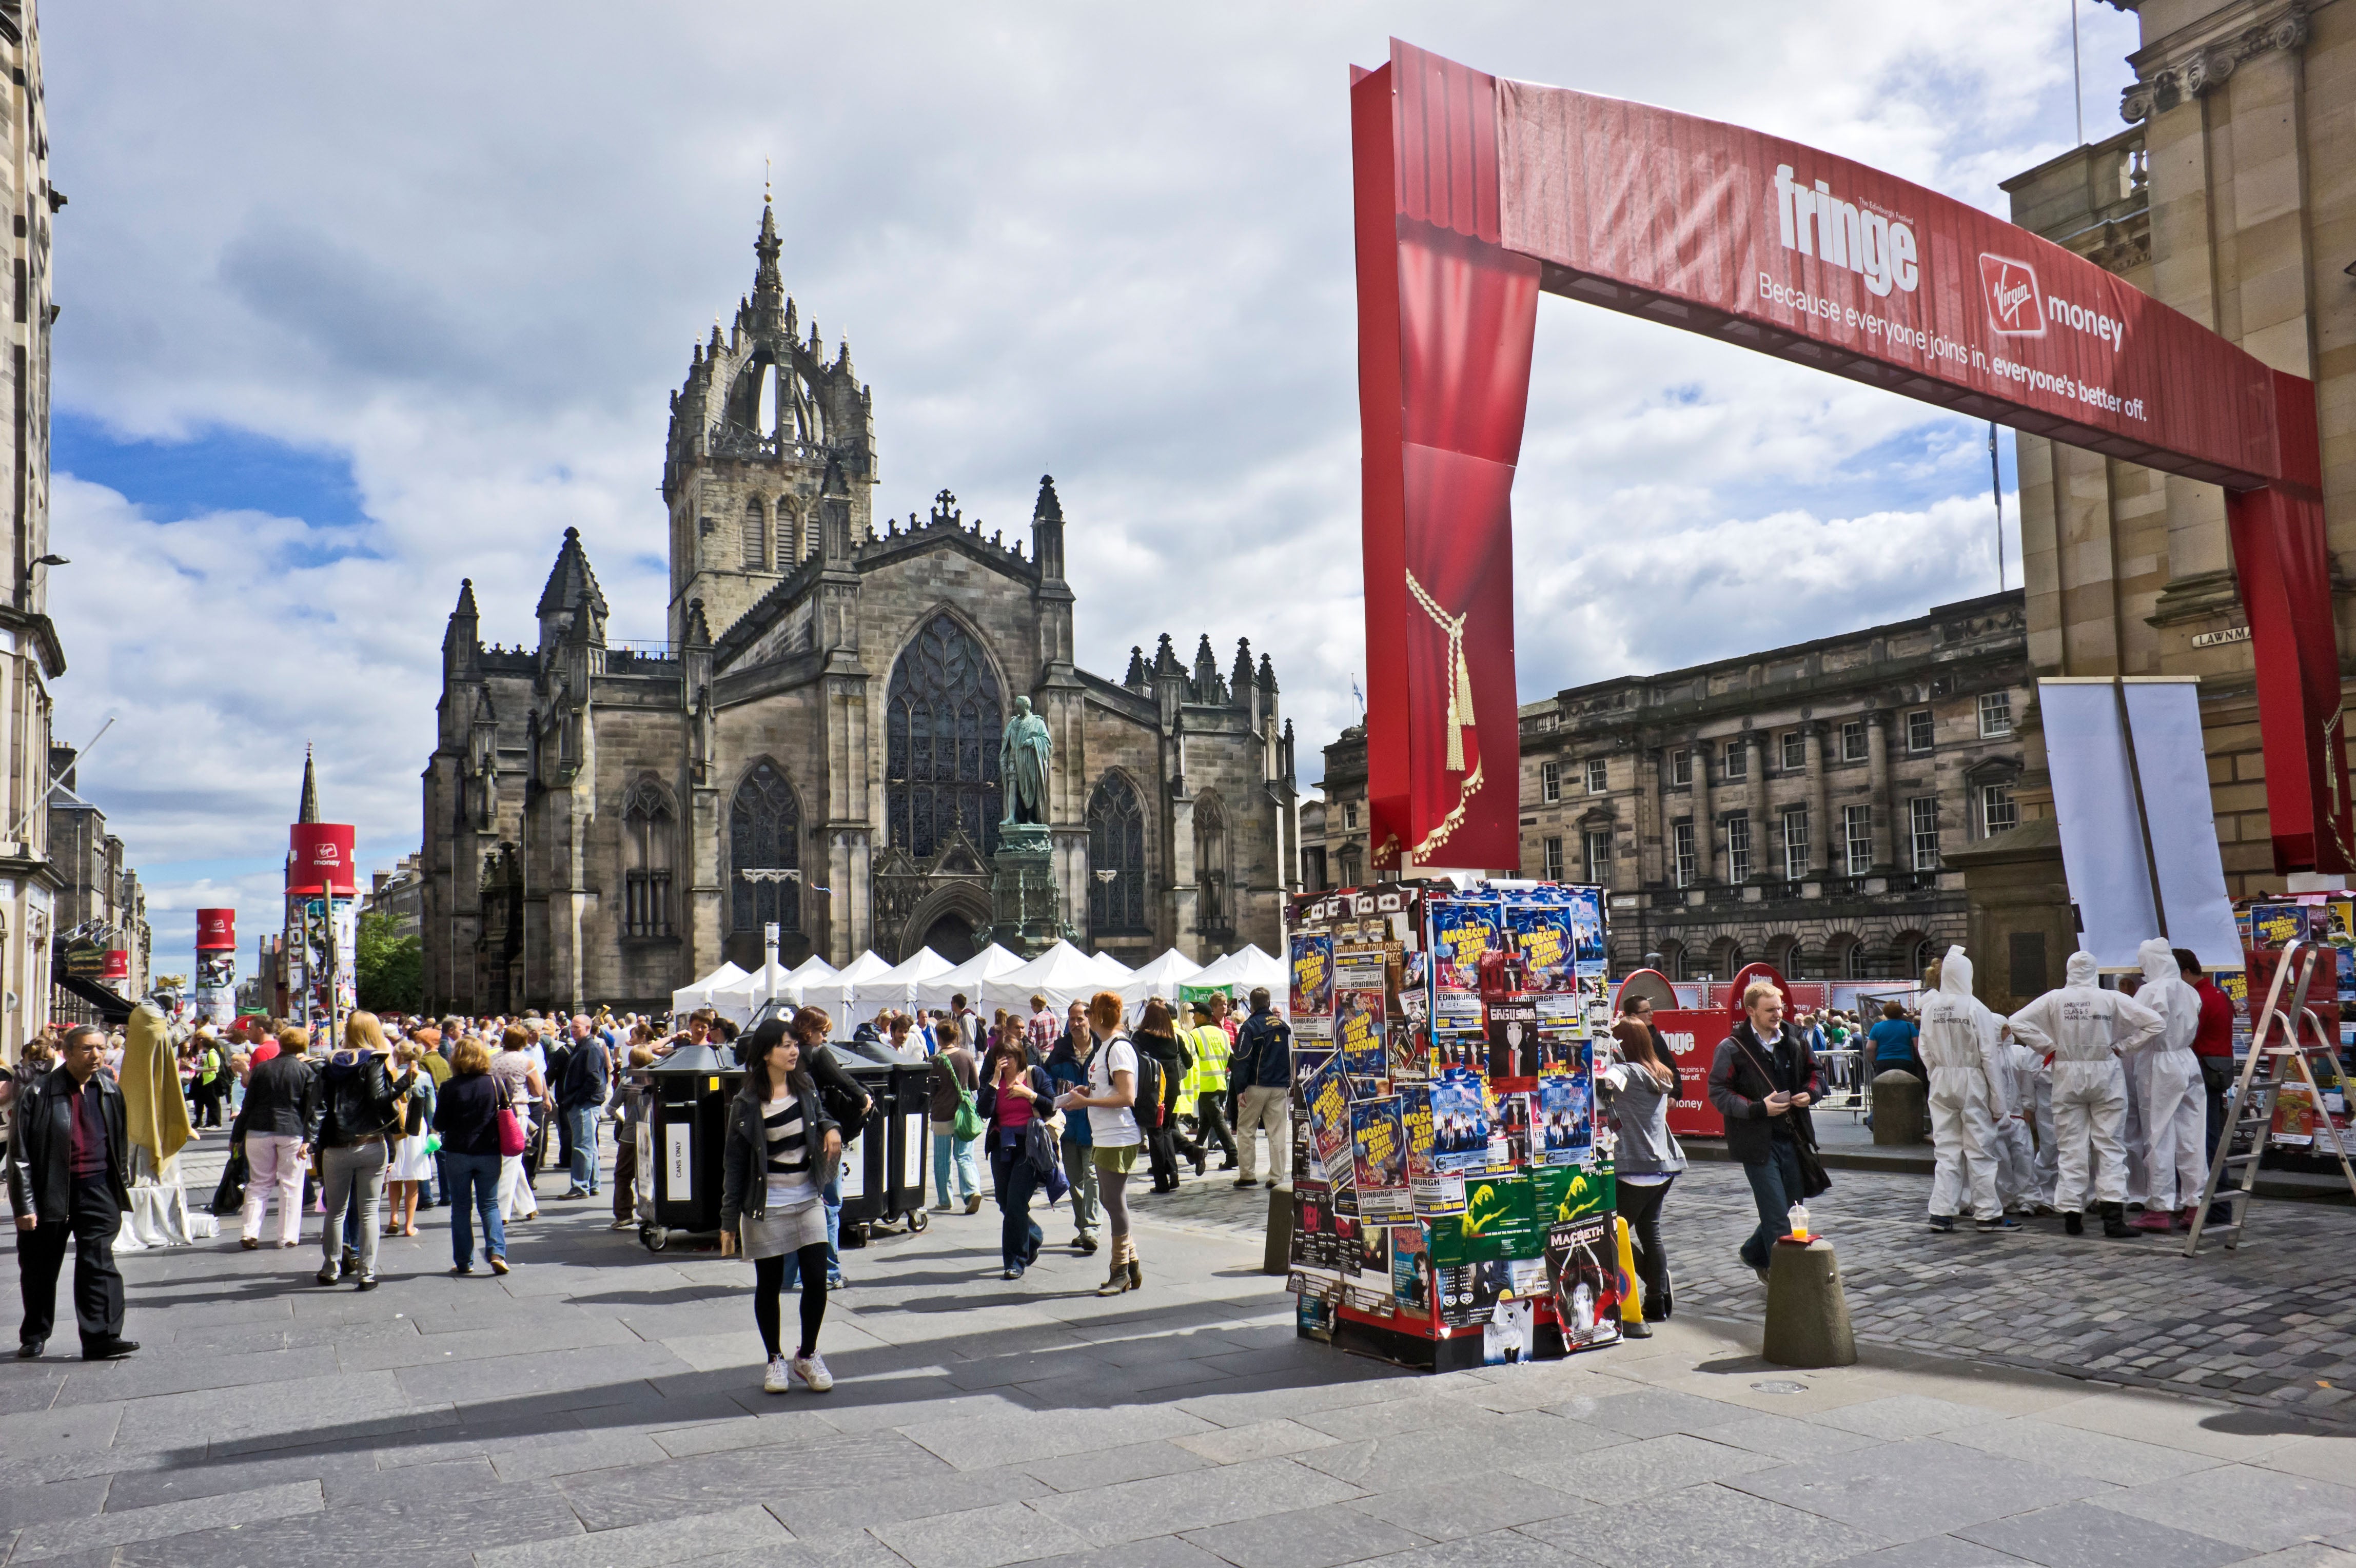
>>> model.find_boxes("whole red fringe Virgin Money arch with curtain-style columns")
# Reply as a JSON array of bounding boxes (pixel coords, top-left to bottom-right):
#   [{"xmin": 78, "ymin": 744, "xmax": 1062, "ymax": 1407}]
[{"xmin": 1350, "ymin": 40, "xmax": 2356, "ymax": 871}]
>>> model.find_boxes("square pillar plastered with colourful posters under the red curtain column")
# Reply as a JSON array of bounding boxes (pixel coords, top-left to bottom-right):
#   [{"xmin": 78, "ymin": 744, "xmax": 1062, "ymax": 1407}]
[{"xmin": 1284, "ymin": 878, "xmax": 1623, "ymax": 1370}]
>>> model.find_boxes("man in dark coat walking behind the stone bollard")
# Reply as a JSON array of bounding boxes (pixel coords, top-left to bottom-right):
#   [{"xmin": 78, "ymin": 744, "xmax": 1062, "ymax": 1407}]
[{"xmin": 1711, "ymin": 979, "xmax": 1831, "ymax": 1281}]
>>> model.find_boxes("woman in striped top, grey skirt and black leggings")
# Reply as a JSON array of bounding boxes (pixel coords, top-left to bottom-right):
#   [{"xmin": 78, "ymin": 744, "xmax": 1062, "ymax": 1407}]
[{"xmin": 721, "ymin": 1008, "xmax": 843, "ymax": 1394}]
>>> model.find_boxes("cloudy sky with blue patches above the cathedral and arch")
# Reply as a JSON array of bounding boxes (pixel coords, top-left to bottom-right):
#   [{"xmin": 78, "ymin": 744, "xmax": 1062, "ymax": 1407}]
[{"xmin": 43, "ymin": 0, "xmax": 2132, "ymax": 970}]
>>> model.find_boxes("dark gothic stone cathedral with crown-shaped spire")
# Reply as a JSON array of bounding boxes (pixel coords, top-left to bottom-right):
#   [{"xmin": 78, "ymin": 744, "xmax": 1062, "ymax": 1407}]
[{"xmin": 424, "ymin": 209, "xmax": 1293, "ymax": 1012}]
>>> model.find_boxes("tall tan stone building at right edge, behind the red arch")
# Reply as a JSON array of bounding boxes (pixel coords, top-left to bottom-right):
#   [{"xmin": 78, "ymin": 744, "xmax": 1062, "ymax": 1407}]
[{"xmin": 1962, "ymin": 0, "xmax": 2356, "ymax": 1005}]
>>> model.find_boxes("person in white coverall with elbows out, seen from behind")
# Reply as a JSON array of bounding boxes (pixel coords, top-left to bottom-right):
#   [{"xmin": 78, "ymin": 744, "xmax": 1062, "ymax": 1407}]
[{"xmin": 2012, "ymin": 951, "xmax": 2168, "ymax": 1236}]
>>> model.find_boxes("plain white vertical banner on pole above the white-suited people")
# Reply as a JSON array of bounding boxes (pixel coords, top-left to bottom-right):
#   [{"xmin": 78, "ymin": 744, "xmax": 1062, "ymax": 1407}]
[{"xmin": 2038, "ymin": 676, "xmax": 2243, "ymax": 970}]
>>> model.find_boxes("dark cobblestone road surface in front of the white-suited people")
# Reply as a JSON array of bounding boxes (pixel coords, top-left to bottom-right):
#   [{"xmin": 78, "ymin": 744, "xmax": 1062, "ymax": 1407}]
[{"xmin": 1133, "ymin": 1144, "xmax": 2356, "ymax": 1427}]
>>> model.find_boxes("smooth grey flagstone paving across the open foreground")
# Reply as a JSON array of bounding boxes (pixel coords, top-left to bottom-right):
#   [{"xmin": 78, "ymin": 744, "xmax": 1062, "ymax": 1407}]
[{"xmin": 0, "ymin": 1134, "xmax": 2356, "ymax": 1568}]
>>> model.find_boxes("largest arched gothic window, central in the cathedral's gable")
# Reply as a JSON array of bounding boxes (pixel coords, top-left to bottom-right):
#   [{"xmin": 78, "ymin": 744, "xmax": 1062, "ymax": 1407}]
[{"xmin": 883, "ymin": 615, "xmax": 1006, "ymax": 859}]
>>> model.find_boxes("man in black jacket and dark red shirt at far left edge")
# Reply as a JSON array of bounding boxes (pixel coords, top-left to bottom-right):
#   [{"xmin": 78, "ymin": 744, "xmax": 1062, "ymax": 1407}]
[{"xmin": 7, "ymin": 1024, "xmax": 139, "ymax": 1361}]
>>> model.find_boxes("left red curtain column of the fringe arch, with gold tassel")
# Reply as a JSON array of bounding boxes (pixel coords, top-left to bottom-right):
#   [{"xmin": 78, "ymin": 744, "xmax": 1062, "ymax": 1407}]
[{"xmin": 1350, "ymin": 45, "xmax": 1539, "ymax": 869}]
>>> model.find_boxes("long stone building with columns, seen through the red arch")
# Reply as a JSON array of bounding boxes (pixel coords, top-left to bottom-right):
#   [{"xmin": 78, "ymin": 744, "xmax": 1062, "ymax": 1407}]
[{"xmin": 1303, "ymin": 591, "xmax": 2029, "ymax": 979}]
